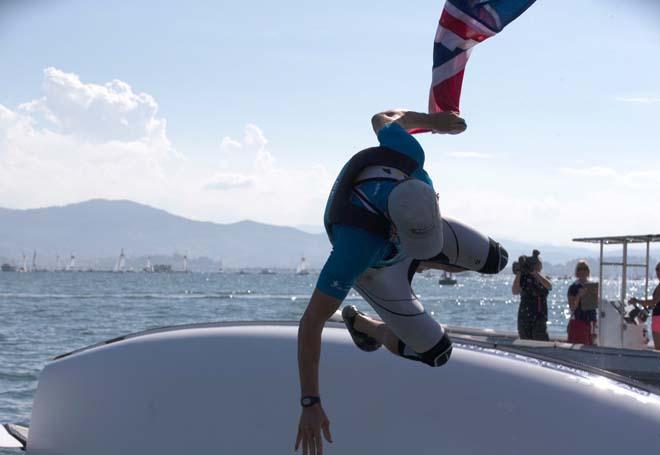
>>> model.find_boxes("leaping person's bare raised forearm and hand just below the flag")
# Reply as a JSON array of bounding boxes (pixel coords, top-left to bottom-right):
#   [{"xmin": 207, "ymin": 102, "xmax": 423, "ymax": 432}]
[{"xmin": 371, "ymin": 109, "xmax": 467, "ymax": 134}]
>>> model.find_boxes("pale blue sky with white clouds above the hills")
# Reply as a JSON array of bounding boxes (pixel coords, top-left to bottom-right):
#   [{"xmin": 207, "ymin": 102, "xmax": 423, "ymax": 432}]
[{"xmin": 0, "ymin": 0, "xmax": 660, "ymax": 245}]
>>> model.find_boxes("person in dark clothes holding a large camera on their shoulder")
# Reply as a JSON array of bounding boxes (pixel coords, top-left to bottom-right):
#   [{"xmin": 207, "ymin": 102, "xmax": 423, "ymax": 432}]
[{"xmin": 511, "ymin": 250, "xmax": 552, "ymax": 341}]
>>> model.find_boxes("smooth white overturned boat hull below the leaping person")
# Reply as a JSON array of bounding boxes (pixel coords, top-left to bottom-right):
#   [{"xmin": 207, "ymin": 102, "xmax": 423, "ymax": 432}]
[{"xmin": 0, "ymin": 322, "xmax": 660, "ymax": 455}]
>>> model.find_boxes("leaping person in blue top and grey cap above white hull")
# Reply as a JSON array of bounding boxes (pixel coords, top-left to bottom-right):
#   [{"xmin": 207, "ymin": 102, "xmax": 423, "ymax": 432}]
[{"xmin": 295, "ymin": 110, "xmax": 508, "ymax": 455}]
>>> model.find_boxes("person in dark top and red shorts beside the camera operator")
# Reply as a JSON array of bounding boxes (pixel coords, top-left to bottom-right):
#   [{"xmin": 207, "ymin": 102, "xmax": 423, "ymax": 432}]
[{"xmin": 568, "ymin": 261, "xmax": 597, "ymax": 346}]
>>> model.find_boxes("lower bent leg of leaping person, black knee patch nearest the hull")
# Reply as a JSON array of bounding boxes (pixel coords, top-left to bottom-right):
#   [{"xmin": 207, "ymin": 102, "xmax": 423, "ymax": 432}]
[{"xmin": 355, "ymin": 259, "xmax": 451, "ymax": 366}]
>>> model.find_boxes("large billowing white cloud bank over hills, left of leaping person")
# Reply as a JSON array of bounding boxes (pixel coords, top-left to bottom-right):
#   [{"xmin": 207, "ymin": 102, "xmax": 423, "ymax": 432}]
[{"xmin": 0, "ymin": 68, "xmax": 334, "ymax": 228}]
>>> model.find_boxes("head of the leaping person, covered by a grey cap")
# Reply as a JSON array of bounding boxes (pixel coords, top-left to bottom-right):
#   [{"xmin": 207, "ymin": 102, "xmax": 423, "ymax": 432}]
[{"xmin": 387, "ymin": 179, "xmax": 444, "ymax": 259}]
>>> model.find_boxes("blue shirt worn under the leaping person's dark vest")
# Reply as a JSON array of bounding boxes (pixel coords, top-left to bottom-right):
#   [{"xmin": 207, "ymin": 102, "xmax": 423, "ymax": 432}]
[{"xmin": 316, "ymin": 123, "xmax": 433, "ymax": 300}]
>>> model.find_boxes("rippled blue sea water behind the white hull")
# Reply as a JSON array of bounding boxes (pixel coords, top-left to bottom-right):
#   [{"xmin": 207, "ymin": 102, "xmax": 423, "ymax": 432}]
[{"xmin": 0, "ymin": 271, "xmax": 643, "ymax": 453}]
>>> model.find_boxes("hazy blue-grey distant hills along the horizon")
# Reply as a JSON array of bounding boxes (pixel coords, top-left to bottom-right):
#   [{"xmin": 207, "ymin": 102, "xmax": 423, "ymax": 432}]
[{"xmin": 0, "ymin": 199, "xmax": 624, "ymax": 268}]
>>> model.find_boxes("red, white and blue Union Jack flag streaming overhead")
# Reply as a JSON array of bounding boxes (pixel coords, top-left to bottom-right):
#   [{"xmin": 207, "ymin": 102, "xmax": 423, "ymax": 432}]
[{"xmin": 429, "ymin": 0, "xmax": 536, "ymax": 113}]
